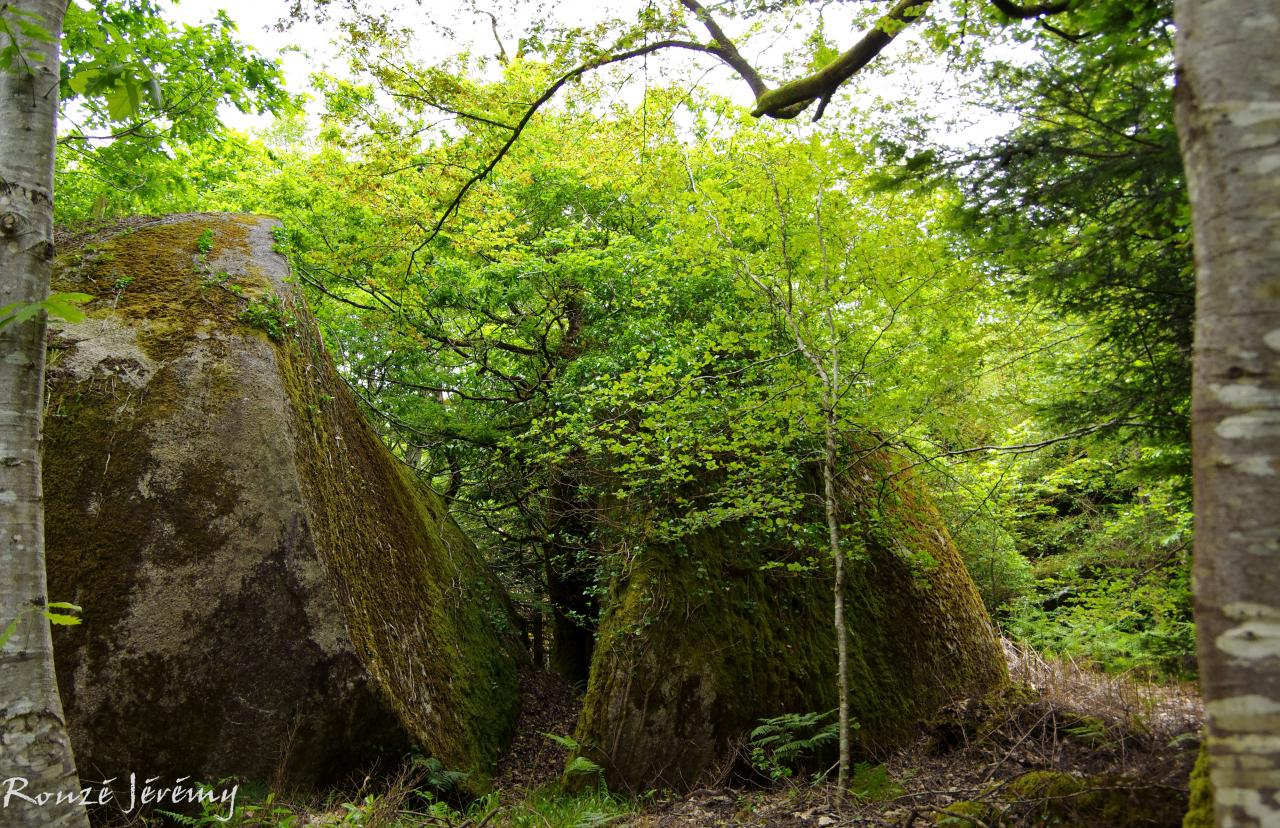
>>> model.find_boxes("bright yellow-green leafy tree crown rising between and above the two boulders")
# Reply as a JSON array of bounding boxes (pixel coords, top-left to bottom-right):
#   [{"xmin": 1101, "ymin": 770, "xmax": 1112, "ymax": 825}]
[{"xmin": 275, "ymin": 67, "xmax": 1034, "ymax": 588}]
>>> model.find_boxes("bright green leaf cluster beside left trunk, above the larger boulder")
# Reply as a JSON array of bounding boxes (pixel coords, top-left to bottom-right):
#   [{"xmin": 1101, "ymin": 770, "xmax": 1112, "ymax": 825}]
[{"xmin": 55, "ymin": 0, "xmax": 293, "ymax": 221}]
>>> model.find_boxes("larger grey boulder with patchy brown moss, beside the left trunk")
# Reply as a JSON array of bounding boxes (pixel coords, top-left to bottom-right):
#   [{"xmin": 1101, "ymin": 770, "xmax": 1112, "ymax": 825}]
[{"xmin": 45, "ymin": 215, "xmax": 520, "ymax": 788}]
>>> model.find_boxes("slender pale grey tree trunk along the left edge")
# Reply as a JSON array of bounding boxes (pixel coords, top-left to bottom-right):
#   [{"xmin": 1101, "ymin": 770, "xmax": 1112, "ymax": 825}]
[{"xmin": 0, "ymin": 0, "xmax": 88, "ymax": 828}]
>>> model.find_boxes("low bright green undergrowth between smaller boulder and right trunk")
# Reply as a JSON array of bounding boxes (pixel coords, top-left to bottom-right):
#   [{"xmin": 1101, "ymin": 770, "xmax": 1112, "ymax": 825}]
[{"xmin": 1006, "ymin": 449, "xmax": 1196, "ymax": 678}]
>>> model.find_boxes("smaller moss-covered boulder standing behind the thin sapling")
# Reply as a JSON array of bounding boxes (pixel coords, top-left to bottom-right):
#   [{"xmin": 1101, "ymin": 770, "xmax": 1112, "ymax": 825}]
[{"xmin": 576, "ymin": 456, "xmax": 1007, "ymax": 790}]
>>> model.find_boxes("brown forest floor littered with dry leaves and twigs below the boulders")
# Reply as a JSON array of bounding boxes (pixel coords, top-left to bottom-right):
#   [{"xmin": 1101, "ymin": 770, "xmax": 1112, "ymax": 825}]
[{"xmin": 490, "ymin": 641, "xmax": 1202, "ymax": 828}]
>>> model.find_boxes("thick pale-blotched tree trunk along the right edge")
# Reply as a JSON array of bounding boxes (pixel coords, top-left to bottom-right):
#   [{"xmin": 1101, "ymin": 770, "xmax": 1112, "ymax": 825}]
[{"xmin": 1175, "ymin": 0, "xmax": 1280, "ymax": 827}]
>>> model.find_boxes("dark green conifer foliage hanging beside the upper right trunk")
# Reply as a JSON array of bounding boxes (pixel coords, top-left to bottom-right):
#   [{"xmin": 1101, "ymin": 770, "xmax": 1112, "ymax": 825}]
[{"xmin": 881, "ymin": 0, "xmax": 1194, "ymax": 460}]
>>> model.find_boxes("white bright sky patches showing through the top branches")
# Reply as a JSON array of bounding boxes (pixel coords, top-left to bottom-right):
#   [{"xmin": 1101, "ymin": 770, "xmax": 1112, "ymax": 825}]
[{"xmin": 164, "ymin": 0, "xmax": 1007, "ymax": 145}]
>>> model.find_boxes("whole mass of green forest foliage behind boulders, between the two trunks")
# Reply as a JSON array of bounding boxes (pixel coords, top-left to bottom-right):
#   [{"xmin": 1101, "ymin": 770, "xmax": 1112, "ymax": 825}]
[{"xmin": 47, "ymin": 4, "xmax": 1194, "ymax": 677}]
